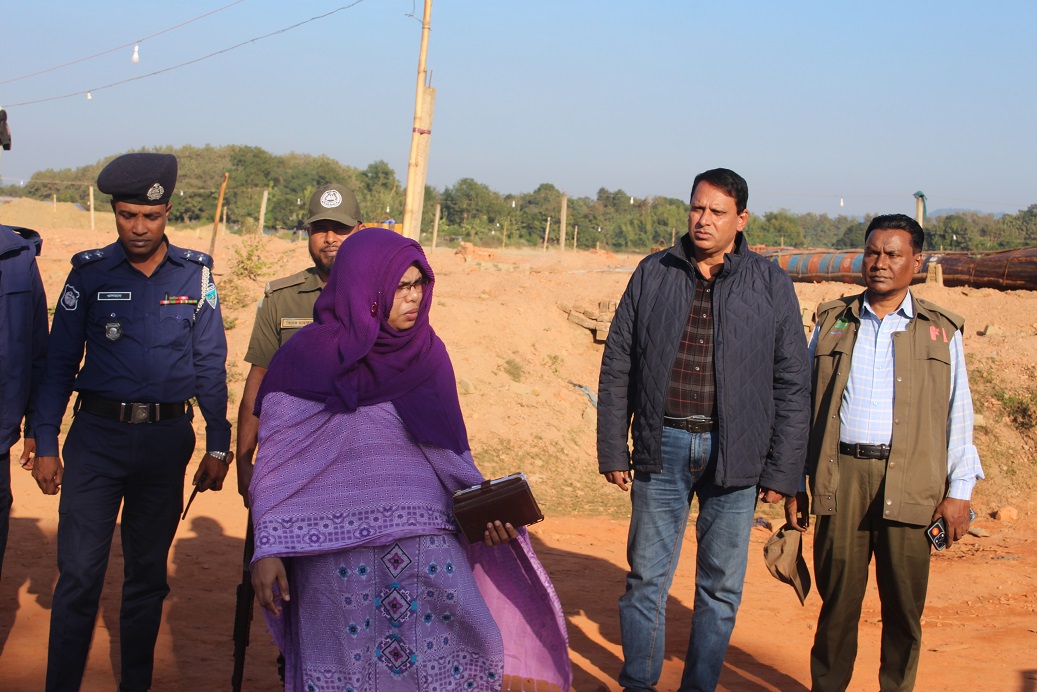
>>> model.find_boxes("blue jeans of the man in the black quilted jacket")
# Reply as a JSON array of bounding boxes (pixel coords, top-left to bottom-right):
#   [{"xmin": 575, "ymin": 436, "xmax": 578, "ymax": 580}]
[{"xmin": 619, "ymin": 427, "xmax": 756, "ymax": 690}]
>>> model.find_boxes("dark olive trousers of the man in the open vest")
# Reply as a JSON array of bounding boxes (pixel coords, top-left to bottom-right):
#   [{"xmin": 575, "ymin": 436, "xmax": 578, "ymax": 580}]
[{"xmin": 810, "ymin": 454, "xmax": 929, "ymax": 692}]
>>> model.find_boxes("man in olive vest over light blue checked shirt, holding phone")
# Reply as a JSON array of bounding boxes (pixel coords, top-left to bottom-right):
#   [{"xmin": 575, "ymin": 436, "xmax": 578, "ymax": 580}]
[{"xmin": 786, "ymin": 214, "xmax": 983, "ymax": 692}]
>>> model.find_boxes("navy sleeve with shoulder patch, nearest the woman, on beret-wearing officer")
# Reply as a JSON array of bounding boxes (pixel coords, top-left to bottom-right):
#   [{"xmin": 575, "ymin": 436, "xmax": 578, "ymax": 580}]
[{"xmin": 192, "ymin": 273, "xmax": 230, "ymax": 451}]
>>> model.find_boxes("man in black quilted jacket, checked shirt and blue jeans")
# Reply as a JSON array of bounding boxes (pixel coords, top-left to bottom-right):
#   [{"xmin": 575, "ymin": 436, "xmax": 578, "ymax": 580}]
[{"xmin": 597, "ymin": 168, "xmax": 810, "ymax": 690}]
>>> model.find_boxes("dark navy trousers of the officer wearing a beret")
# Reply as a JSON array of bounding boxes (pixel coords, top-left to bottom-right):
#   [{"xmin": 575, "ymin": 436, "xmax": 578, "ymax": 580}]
[{"xmin": 47, "ymin": 412, "xmax": 195, "ymax": 692}]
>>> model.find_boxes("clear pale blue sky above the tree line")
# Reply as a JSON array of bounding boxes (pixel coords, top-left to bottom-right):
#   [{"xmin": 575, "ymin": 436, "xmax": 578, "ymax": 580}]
[{"xmin": 0, "ymin": 0, "xmax": 1037, "ymax": 215}]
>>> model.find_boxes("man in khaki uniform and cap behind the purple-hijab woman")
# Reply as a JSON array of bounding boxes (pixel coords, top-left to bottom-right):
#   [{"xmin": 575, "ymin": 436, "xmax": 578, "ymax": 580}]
[{"xmin": 236, "ymin": 183, "xmax": 363, "ymax": 506}]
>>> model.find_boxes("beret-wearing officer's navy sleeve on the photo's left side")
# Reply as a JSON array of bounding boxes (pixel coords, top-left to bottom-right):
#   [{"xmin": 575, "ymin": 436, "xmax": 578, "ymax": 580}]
[{"xmin": 34, "ymin": 269, "xmax": 88, "ymax": 456}]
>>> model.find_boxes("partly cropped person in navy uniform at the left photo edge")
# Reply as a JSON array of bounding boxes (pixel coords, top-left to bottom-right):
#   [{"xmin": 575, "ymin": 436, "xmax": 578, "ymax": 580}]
[{"xmin": 0, "ymin": 226, "xmax": 48, "ymax": 572}]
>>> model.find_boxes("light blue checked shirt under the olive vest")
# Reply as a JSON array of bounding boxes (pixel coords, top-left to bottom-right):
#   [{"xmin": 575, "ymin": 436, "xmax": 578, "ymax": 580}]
[{"xmin": 809, "ymin": 292, "xmax": 984, "ymax": 500}]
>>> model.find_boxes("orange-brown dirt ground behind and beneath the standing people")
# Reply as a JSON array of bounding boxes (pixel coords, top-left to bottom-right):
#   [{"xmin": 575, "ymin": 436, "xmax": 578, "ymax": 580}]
[{"xmin": 6, "ymin": 200, "xmax": 1037, "ymax": 692}]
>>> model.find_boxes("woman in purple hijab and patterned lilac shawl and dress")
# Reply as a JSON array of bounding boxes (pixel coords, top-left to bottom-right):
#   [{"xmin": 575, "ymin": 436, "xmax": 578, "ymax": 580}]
[{"xmin": 250, "ymin": 228, "xmax": 571, "ymax": 692}]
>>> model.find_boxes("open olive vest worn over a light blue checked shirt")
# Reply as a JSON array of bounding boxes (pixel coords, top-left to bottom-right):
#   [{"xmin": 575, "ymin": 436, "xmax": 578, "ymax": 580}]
[{"xmin": 807, "ymin": 294, "xmax": 964, "ymax": 525}]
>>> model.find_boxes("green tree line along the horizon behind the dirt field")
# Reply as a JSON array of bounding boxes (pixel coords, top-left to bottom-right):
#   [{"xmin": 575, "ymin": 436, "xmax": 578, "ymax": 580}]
[{"xmin": 0, "ymin": 145, "xmax": 1037, "ymax": 252}]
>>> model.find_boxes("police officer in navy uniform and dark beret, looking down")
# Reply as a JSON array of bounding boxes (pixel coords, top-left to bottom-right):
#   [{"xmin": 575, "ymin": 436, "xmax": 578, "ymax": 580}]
[{"xmin": 32, "ymin": 154, "xmax": 232, "ymax": 692}]
